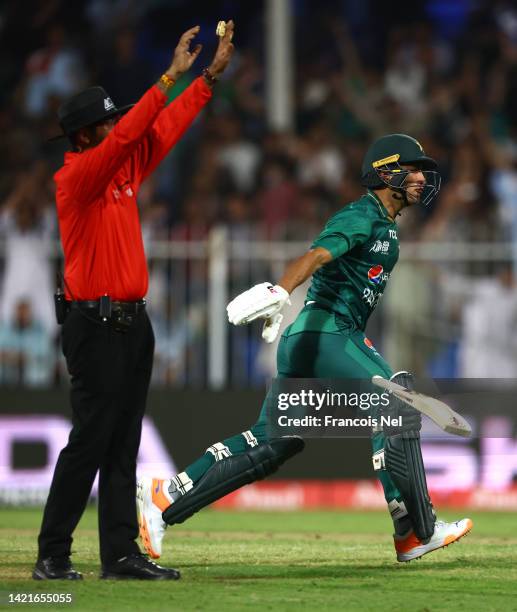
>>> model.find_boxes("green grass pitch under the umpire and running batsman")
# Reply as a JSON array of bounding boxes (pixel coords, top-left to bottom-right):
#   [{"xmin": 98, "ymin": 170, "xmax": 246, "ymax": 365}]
[{"xmin": 0, "ymin": 509, "xmax": 517, "ymax": 612}]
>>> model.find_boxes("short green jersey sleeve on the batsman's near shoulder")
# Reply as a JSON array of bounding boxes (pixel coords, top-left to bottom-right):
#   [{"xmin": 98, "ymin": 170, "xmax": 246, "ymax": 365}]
[{"xmin": 311, "ymin": 206, "xmax": 372, "ymax": 259}]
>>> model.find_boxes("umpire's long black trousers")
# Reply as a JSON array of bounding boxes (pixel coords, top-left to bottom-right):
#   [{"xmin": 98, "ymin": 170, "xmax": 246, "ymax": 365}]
[{"xmin": 38, "ymin": 310, "xmax": 154, "ymax": 565}]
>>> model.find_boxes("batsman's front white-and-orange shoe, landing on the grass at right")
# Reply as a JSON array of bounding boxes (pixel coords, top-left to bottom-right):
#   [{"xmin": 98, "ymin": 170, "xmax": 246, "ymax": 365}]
[{"xmin": 393, "ymin": 519, "xmax": 473, "ymax": 562}]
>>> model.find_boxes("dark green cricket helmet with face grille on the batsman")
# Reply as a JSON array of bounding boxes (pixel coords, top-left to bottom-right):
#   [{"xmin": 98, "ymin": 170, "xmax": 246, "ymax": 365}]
[{"xmin": 361, "ymin": 134, "xmax": 441, "ymax": 205}]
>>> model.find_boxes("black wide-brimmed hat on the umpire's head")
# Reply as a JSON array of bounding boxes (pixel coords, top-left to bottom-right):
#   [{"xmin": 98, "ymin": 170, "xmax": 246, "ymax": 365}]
[{"xmin": 51, "ymin": 86, "xmax": 134, "ymax": 140}]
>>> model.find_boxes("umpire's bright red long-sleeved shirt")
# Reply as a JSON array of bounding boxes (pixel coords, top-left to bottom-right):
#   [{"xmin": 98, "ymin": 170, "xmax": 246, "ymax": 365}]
[{"xmin": 54, "ymin": 78, "xmax": 212, "ymax": 301}]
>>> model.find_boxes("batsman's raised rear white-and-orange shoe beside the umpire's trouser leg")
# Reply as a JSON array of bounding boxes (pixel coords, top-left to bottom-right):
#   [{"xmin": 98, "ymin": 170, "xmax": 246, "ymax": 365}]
[{"xmin": 136, "ymin": 477, "xmax": 172, "ymax": 559}]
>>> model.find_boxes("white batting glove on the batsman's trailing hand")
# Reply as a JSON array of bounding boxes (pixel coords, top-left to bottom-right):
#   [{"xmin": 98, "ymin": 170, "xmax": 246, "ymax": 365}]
[{"xmin": 226, "ymin": 283, "xmax": 291, "ymax": 328}]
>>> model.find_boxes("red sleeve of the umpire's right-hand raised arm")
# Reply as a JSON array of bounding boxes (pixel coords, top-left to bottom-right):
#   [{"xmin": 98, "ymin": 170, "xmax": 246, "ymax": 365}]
[{"xmin": 137, "ymin": 77, "xmax": 212, "ymax": 181}]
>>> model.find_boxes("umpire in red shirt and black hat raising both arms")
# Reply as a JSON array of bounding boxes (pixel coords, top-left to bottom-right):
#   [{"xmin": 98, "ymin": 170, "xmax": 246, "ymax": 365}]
[{"xmin": 33, "ymin": 21, "xmax": 233, "ymax": 580}]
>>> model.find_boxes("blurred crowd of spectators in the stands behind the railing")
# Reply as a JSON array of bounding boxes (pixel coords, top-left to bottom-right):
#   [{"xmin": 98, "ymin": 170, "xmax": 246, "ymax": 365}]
[{"xmin": 0, "ymin": 0, "xmax": 517, "ymax": 386}]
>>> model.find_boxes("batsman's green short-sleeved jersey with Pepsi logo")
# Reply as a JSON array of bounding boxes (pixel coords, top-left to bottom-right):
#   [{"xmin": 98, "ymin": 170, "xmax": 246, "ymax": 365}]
[{"xmin": 307, "ymin": 191, "xmax": 399, "ymax": 330}]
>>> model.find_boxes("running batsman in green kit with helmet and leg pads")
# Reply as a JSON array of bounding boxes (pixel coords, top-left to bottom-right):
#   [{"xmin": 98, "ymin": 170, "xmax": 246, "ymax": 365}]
[{"xmin": 137, "ymin": 134, "xmax": 472, "ymax": 562}]
